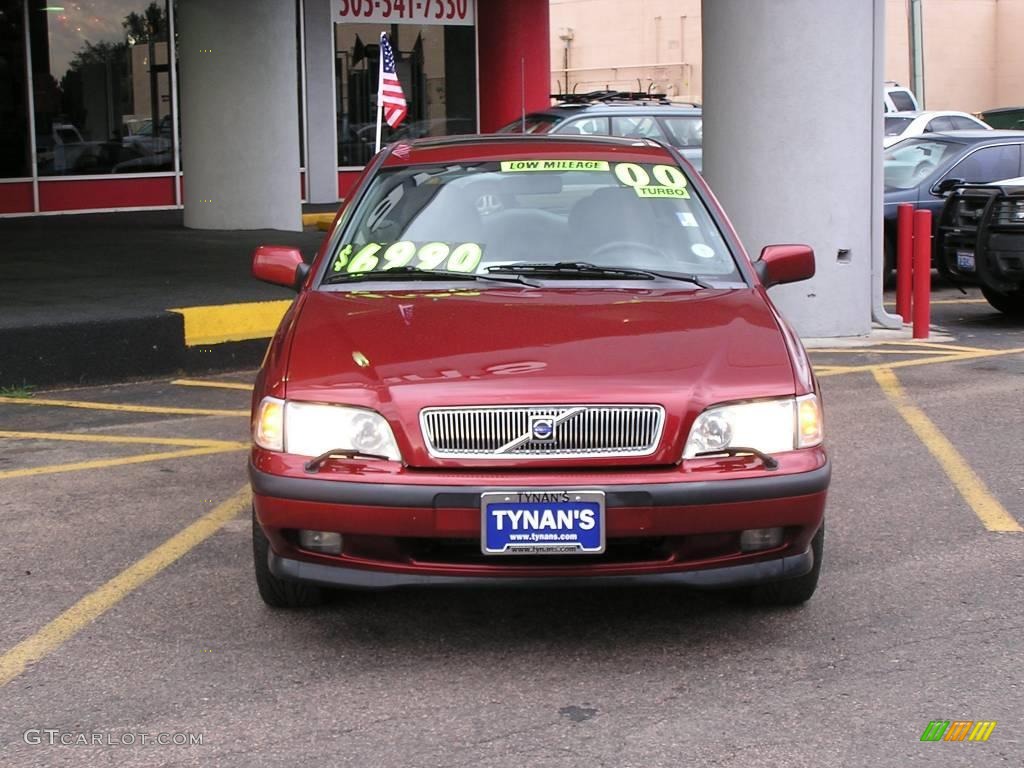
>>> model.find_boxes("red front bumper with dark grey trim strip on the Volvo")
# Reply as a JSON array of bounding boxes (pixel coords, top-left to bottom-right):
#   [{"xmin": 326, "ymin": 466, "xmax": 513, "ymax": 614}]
[{"xmin": 250, "ymin": 454, "xmax": 830, "ymax": 589}]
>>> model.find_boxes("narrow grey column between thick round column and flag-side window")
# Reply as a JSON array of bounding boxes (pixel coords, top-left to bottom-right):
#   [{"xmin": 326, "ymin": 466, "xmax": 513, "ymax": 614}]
[{"xmin": 303, "ymin": 0, "xmax": 338, "ymax": 203}]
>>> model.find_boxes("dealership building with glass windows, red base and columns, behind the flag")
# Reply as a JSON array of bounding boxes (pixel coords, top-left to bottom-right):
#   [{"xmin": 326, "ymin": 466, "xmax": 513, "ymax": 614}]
[{"xmin": 0, "ymin": 0, "xmax": 550, "ymax": 229}]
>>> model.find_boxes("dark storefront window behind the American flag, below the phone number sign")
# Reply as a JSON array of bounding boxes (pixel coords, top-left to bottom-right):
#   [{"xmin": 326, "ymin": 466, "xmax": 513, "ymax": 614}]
[{"xmin": 335, "ymin": 24, "xmax": 476, "ymax": 166}]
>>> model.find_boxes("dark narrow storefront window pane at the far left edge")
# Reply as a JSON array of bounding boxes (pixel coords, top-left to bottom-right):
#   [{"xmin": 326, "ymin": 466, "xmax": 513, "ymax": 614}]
[{"xmin": 0, "ymin": 0, "xmax": 32, "ymax": 178}]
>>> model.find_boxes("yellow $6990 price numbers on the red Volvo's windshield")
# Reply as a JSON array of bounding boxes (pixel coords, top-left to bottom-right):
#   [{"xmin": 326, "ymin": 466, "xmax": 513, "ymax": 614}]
[{"xmin": 331, "ymin": 240, "xmax": 483, "ymax": 274}]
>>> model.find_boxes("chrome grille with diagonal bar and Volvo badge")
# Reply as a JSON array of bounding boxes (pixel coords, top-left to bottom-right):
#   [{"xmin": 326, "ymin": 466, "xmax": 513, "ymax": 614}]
[{"xmin": 420, "ymin": 406, "xmax": 665, "ymax": 459}]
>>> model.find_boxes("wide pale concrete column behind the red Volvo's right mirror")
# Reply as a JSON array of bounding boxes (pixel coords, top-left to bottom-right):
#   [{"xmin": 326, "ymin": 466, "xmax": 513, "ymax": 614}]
[{"xmin": 702, "ymin": 0, "xmax": 882, "ymax": 337}]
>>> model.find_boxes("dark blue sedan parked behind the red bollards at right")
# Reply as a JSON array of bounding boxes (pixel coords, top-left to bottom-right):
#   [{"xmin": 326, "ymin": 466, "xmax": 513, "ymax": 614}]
[{"xmin": 883, "ymin": 130, "xmax": 1024, "ymax": 271}]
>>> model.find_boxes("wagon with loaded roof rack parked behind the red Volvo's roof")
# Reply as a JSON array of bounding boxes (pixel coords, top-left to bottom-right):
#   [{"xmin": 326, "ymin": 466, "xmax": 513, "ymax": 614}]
[{"xmin": 499, "ymin": 91, "xmax": 703, "ymax": 171}]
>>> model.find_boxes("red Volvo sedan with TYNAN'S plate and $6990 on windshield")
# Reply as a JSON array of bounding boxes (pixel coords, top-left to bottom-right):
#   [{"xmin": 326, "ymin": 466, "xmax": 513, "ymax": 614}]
[{"xmin": 249, "ymin": 135, "xmax": 829, "ymax": 607}]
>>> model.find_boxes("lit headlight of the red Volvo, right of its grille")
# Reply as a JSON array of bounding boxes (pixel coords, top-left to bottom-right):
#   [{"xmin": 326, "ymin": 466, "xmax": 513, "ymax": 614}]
[{"xmin": 683, "ymin": 394, "xmax": 821, "ymax": 459}]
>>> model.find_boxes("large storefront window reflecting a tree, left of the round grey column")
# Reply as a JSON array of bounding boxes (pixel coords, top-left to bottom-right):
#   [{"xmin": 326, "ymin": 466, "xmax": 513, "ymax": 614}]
[{"xmin": 28, "ymin": 0, "xmax": 174, "ymax": 176}]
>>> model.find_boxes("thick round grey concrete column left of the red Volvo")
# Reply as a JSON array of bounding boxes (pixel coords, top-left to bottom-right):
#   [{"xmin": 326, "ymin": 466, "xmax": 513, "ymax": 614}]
[{"xmin": 177, "ymin": 0, "xmax": 302, "ymax": 230}]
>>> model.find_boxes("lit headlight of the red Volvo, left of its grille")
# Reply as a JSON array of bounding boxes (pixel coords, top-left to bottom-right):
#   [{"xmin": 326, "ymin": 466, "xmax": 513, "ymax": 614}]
[{"xmin": 253, "ymin": 397, "xmax": 401, "ymax": 461}]
